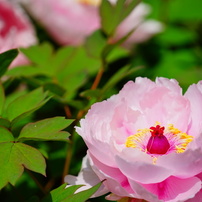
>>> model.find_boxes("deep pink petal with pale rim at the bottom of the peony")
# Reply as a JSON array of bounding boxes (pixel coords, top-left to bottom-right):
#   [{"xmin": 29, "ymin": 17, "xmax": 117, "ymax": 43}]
[{"xmin": 143, "ymin": 176, "xmax": 201, "ymax": 202}]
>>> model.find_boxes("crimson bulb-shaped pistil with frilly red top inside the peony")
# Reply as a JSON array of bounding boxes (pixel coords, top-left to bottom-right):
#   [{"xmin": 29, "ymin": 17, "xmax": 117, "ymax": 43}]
[{"xmin": 147, "ymin": 125, "xmax": 170, "ymax": 154}]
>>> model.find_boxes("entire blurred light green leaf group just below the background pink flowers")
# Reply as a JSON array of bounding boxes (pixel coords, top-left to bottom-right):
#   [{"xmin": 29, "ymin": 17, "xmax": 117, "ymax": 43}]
[{"xmin": 6, "ymin": 43, "xmax": 101, "ymax": 101}]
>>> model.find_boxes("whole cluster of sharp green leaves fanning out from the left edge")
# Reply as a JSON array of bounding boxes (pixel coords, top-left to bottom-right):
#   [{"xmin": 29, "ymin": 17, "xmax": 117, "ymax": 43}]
[{"xmin": 0, "ymin": 86, "xmax": 73, "ymax": 189}]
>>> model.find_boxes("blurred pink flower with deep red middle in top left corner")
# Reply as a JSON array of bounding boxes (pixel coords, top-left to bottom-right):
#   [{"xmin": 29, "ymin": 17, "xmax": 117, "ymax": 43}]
[{"xmin": 0, "ymin": 0, "xmax": 37, "ymax": 66}]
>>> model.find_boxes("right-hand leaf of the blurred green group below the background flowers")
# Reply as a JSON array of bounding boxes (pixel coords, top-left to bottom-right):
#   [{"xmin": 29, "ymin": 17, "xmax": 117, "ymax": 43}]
[{"xmin": 57, "ymin": 47, "xmax": 101, "ymax": 100}]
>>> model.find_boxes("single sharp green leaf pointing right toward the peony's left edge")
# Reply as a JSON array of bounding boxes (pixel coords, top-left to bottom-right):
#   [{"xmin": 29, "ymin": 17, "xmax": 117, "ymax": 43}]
[{"xmin": 18, "ymin": 117, "xmax": 73, "ymax": 141}]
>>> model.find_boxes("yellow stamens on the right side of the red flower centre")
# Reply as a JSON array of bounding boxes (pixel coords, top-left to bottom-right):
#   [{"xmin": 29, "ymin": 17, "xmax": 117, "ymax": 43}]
[{"xmin": 168, "ymin": 124, "xmax": 193, "ymax": 153}]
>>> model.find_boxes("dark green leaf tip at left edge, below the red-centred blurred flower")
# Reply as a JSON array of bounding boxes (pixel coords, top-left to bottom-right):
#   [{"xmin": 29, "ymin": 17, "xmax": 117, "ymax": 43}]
[{"xmin": 0, "ymin": 49, "xmax": 18, "ymax": 77}]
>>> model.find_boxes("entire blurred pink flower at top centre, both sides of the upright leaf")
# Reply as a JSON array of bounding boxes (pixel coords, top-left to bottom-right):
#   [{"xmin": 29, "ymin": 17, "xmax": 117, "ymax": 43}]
[{"xmin": 21, "ymin": 0, "xmax": 162, "ymax": 46}]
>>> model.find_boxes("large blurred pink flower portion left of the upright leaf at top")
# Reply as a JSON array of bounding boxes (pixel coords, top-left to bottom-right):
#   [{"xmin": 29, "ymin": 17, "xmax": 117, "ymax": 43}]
[{"xmin": 21, "ymin": 0, "xmax": 100, "ymax": 45}]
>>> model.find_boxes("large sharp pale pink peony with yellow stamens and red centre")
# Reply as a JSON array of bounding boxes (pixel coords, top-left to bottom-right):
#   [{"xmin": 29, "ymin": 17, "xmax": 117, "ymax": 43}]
[{"xmin": 65, "ymin": 78, "xmax": 202, "ymax": 202}]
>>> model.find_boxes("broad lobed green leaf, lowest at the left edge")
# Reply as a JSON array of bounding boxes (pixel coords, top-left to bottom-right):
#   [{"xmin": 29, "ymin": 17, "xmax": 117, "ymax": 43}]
[{"xmin": 0, "ymin": 142, "xmax": 46, "ymax": 189}]
